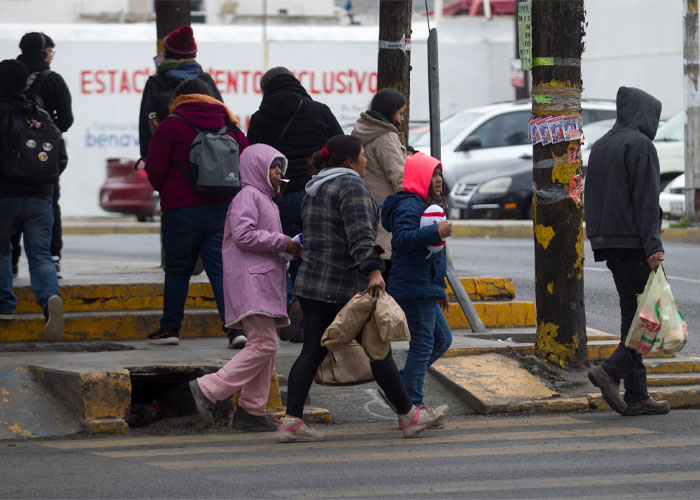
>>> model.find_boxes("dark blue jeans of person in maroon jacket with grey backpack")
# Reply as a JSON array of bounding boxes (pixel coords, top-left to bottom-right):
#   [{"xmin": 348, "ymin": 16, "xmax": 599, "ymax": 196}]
[{"xmin": 160, "ymin": 202, "xmax": 229, "ymax": 330}]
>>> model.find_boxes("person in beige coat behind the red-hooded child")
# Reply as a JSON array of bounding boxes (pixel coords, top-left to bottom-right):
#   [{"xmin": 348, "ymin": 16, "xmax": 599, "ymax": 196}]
[{"xmin": 352, "ymin": 88, "xmax": 406, "ymax": 276}]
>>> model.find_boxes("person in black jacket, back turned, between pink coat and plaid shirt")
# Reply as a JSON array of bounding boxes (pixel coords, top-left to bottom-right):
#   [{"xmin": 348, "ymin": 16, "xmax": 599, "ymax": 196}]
[{"xmin": 248, "ymin": 66, "xmax": 343, "ymax": 342}]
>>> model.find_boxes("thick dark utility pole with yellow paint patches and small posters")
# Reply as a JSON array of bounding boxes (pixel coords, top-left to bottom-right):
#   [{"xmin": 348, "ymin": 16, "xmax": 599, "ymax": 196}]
[{"xmin": 530, "ymin": 0, "xmax": 588, "ymax": 370}]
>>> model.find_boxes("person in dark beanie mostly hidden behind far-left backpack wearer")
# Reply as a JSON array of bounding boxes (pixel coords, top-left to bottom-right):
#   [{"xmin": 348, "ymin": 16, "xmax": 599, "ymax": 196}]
[{"xmin": 12, "ymin": 32, "xmax": 73, "ymax": 278}]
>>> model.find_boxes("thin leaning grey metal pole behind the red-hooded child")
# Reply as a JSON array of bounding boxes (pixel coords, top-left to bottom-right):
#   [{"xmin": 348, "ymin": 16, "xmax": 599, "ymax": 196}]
[{"xmin": 428, "ymin": 28, "xmax": 486, "ymax": 333}]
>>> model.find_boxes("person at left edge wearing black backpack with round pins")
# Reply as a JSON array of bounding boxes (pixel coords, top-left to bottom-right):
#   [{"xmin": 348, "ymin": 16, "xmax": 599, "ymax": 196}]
[{"xmin": 0, "ymin": 59, "xmax": 68, "ymax": 341}]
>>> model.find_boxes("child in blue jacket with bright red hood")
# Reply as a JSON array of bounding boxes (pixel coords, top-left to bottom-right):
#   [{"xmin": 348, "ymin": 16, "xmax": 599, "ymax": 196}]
[{"xmin": 382, "ymin": 153, "xmax": 452, "ymax": 414}]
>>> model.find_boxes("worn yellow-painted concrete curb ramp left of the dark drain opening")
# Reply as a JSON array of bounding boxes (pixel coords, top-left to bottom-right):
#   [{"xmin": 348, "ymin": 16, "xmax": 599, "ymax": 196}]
[{"xmin": 29, "ymin": 366, "xmax": 131, "ymax": 422}]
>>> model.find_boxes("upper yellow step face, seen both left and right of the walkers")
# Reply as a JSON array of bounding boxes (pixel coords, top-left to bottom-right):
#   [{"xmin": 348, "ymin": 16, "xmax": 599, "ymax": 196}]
[{"xmin": 14, "ymin": 278, "xmax": 515, "ymax": 314}]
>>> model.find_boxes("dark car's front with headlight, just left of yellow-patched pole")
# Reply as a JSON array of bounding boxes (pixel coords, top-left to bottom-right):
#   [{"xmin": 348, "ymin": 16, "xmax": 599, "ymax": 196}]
[{"xmin": 449, "ymin": 158, "xmax": 532, "ymax": 219}]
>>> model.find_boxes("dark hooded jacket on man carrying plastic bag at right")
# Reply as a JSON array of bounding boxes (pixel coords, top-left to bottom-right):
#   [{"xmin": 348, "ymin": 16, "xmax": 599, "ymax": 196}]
[{"xmin": 584, "ymin": 87, "xmax": 663, "ymax": 257}]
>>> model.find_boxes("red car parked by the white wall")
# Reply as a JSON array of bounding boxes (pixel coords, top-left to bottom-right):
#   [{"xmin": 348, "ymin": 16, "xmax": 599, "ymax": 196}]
[{"xmin": 100, "ymin": 158, "xmax": 160, "ymax": 222}]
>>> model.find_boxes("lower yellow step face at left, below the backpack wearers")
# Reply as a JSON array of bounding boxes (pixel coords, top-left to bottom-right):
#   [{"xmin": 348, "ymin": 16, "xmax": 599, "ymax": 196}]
[{"xmin": 0, "ymin": 309, "xmax": 225, "ymax": 342}]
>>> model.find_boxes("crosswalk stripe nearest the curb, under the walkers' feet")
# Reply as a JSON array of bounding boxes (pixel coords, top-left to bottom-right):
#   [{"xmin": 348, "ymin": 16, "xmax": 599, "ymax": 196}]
[{"xmin": 43, "ymin": 416, "xmax": 591, "ymax": 450}]
